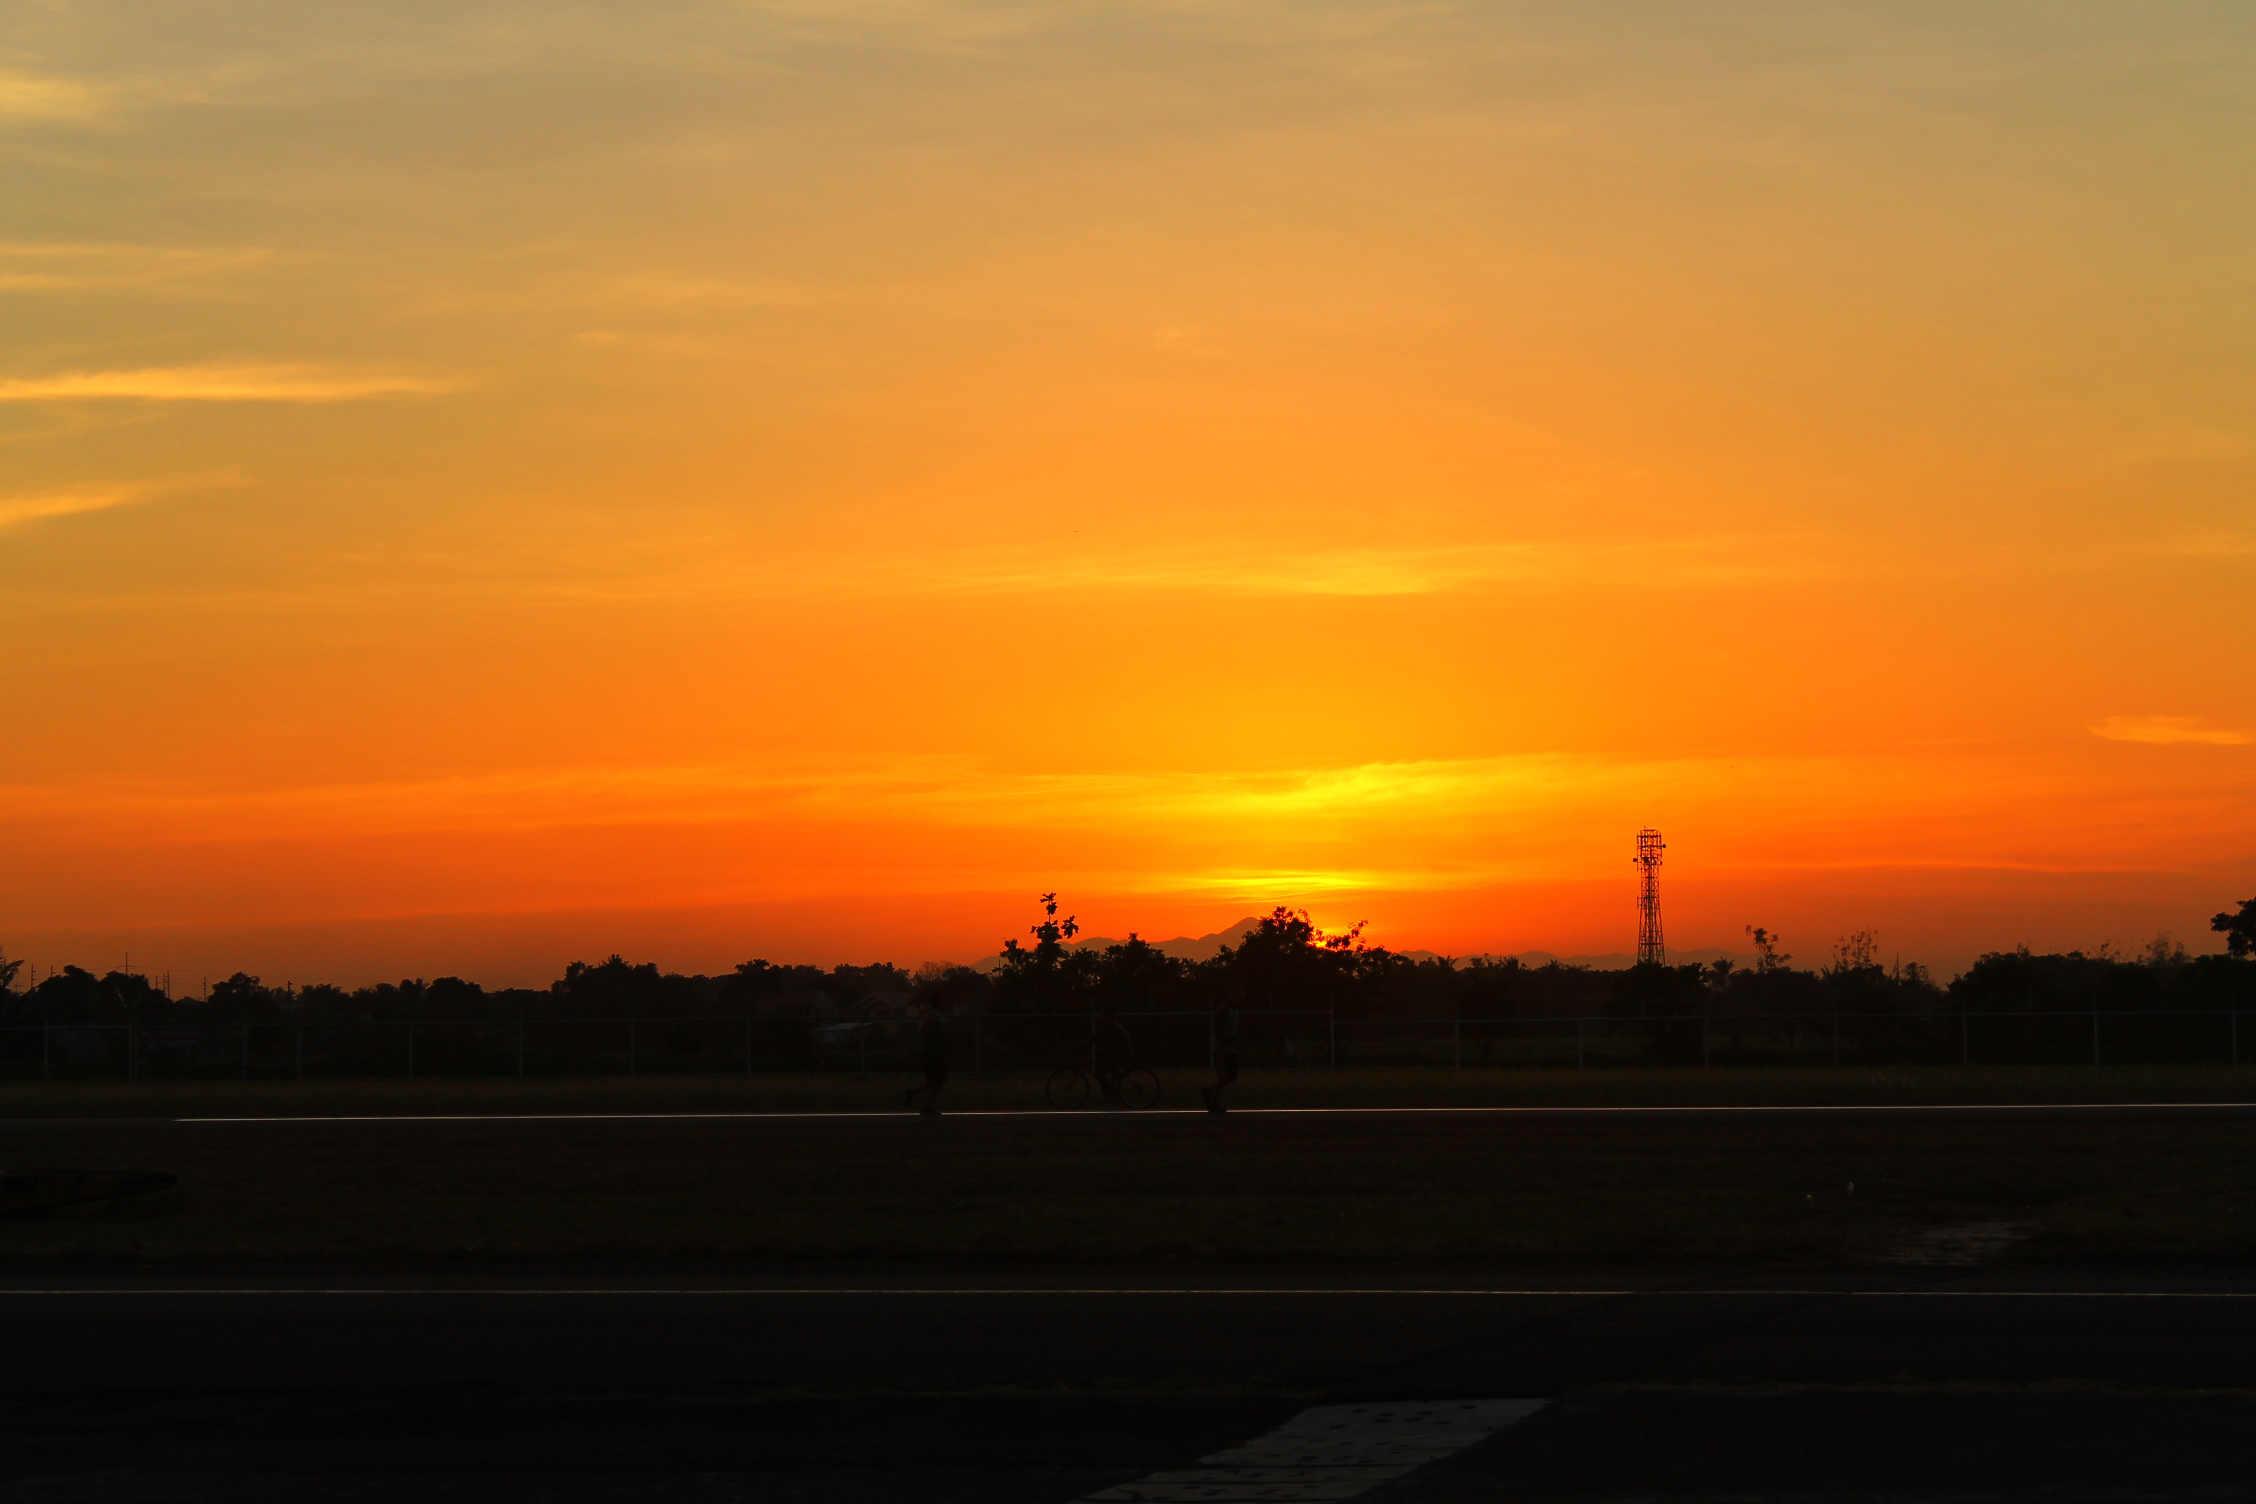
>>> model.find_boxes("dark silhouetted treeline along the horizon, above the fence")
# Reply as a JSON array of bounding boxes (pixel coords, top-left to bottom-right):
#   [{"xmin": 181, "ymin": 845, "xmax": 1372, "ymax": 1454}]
[{"xmin": 0, "ymin": 895, "xmax": 2256, "ymax": 1026}]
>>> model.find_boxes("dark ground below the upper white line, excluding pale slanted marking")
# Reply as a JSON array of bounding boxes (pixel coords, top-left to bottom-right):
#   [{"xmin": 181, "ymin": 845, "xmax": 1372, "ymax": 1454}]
[{"xmin": 13, "ymin": 1107, "xmax": 2256, "ymax": 1504}]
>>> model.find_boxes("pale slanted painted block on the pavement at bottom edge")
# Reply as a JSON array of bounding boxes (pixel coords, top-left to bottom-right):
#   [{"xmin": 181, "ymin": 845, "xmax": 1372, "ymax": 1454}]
[{"xmin": 1076, "ymin": 1400, "xmax": 1545, "ymax": 1504}]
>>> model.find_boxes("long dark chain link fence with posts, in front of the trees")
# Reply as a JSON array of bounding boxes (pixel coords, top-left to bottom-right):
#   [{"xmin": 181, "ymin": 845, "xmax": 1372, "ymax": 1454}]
[{"xmin": 0, "ymin": 1010, "xmax": 2240, "ymax": 1080}]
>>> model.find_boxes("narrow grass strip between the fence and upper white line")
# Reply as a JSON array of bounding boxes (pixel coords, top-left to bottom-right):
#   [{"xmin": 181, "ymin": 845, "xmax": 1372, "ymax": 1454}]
[{"xmin": 0, "ymin": 1067, "xmax": 2256, "ymax": 1121}]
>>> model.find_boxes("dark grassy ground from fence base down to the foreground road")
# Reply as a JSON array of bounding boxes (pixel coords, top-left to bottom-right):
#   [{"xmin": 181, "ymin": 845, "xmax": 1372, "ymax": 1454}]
[{"xmin": 0, "ymin": 1071, "xmax": 2256, "ymax": 1267}]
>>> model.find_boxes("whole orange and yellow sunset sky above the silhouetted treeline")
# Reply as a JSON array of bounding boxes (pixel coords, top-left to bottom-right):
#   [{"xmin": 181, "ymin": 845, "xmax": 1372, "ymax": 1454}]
[{"xmin": 0, "ymin": 0, "xmax": 2256, "ymax": 985}]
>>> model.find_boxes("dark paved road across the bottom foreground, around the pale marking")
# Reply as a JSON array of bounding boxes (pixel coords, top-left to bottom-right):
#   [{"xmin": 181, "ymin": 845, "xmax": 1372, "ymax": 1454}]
[{"xmin": 0, "ymin": 1265, "xmax": 2256, "ymax": 1504}]
